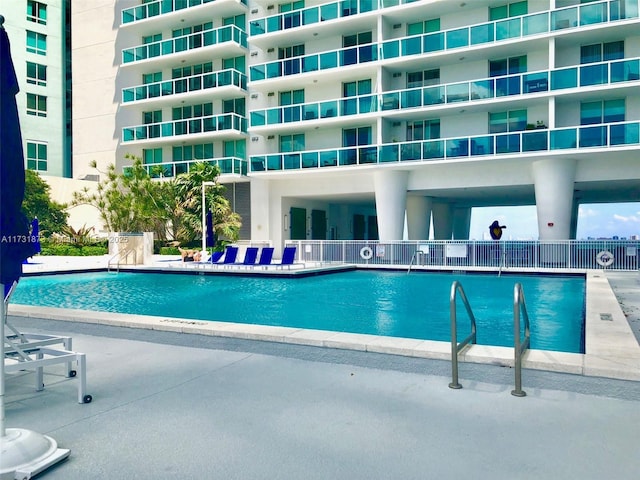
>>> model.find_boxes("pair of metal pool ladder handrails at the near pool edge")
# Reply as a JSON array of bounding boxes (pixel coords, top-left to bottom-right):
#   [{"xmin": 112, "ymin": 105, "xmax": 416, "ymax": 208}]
[{"xmin": 449, "ymin": 280, "xmax": 531, "ymax": 397}]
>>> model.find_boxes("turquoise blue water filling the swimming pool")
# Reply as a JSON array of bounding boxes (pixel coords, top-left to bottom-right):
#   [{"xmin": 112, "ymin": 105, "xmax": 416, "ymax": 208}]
[{"xmin": 11, "ymin": 270, "xmax": 585, "ymax": 353}]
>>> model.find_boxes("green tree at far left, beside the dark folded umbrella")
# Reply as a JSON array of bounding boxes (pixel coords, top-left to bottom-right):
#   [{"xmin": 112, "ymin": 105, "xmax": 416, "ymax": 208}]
[{"xmin": 22, "ymin": 170, "xmax": 69, "ymax": 234}]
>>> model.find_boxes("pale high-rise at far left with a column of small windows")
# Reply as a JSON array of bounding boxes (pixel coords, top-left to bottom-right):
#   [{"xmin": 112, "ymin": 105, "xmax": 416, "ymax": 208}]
[{"xmin": 0, "ymin": 0, "xmax": 72, "ymax": 178}]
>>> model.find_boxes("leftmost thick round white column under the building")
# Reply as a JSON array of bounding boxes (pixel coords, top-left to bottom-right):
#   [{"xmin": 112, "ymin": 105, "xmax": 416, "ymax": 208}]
[{"xmin": 373, "ymin": 169, "xmax": 409, "ymax": 241}]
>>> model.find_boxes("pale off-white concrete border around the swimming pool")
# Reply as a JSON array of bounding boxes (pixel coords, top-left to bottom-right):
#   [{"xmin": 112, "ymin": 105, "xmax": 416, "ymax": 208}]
[{"xmin": 9, "ymin": 256, "xmax": 640, "ymax": 380}]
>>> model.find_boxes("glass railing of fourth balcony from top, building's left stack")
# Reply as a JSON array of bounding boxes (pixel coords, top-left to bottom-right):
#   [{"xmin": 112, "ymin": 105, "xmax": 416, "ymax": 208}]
[{"xmin": 122, "ymin": 113, "xmax": 247, "ymax": 142}]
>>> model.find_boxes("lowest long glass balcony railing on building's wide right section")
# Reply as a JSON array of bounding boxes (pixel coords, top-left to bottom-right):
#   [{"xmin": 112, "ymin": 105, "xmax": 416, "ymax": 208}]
[{"xmin": 250, "ymin": 122, "xmax": 640, "ymax": 172}]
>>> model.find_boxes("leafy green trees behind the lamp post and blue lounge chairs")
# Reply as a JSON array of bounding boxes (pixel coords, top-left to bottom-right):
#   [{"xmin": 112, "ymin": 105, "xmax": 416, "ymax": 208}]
[{"xmin": 73, "ymin": 155, "xmax": 241, "ymax": 242}]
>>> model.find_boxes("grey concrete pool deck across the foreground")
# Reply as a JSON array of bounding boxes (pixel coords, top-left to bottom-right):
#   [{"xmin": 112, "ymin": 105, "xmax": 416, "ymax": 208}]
[{"xmin": 6, "ymin": 255, "xmax": 640, "ymax": 480}]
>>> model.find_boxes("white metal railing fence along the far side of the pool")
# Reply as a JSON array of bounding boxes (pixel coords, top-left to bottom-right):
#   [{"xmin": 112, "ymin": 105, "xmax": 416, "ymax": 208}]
[{"xmin": 285, "ymin": 240, "xmax": 640, "ymax": 272}]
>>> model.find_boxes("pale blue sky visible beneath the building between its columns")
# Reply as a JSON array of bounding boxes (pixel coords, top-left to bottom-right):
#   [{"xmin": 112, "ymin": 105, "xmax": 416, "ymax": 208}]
[{"xmin": 469, "ymin": 203, "xmax": 640, "ymax": 240}]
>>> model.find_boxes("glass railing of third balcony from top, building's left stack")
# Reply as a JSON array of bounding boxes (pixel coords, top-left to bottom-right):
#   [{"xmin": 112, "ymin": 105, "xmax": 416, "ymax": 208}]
[{"xmin": 122, "ymin": 69, "xmax": 247, "ymax": 103}]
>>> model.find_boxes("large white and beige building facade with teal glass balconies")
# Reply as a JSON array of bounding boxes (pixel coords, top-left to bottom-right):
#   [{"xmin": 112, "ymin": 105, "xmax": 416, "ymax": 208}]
[{"xmin": 72, "ymin": 0, "xmax": 640, "ymax": 246}]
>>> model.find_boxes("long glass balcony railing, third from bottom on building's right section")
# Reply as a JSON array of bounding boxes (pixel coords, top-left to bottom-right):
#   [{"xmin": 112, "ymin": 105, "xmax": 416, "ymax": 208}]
[{"xmin": 250, "ymin": 0, "xmax": 639, "ymax": 81}]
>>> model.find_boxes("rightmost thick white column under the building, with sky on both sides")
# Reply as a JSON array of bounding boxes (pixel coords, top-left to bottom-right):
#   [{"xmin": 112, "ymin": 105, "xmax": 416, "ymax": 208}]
[{"xmin": 532, "ymin": 158, "xmax": 576, "ymax": 240}]
